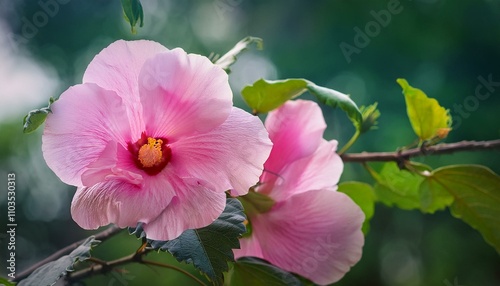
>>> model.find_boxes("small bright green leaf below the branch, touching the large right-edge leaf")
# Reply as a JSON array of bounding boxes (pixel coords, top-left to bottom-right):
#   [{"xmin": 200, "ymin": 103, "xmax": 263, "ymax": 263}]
[{"xmin": 372, "ymin": 162, "xmax": 424, "ymax": 210}]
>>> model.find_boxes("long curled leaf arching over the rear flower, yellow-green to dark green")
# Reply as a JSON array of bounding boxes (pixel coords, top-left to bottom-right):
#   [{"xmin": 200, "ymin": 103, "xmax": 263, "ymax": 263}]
[{"xmin": 241, "ymin": 78, "xmax": 363, "ymax": 126}]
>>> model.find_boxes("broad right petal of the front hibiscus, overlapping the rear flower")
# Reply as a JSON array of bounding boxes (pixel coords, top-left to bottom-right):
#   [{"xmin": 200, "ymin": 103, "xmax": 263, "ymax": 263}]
[{"xmin": 171, "ymin": 108, "xmax": 272, "ymax": 195}]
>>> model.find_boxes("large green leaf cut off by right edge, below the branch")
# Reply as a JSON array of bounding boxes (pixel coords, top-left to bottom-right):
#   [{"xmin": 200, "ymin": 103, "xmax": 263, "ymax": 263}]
[{"xmin": 424, "ymin": 165, "xmax": 500, "ymax": 253}]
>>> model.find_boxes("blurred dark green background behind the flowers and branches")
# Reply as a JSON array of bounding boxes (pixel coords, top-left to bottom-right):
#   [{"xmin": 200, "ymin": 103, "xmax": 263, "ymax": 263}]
[{"xmin": 0, "ymin": 0, "xmax": 500, "ymax": 286}]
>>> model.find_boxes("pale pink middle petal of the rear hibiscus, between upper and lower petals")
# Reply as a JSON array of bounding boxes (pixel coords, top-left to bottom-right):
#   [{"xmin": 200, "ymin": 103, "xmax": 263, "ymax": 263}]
[{"xmin": 262, "ymin": 140, "xmax": 344, "ymax": 201}]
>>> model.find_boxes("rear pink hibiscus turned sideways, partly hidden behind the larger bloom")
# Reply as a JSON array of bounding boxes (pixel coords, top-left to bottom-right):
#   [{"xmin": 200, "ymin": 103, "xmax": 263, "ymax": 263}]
[{"xmin": 234, "ymin": 100, "xmax": 364, "ymax": 284}]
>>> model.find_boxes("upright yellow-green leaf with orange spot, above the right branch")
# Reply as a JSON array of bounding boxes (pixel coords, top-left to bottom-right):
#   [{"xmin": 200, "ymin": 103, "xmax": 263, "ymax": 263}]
[{"xmin": 397, "ymin": 78, "xmax": 451, "ymax": 141}]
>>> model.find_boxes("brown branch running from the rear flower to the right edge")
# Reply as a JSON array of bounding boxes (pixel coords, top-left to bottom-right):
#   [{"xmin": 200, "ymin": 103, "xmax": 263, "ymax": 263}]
[{"xmin": 341, "ymin": 140, "xmax": 500, "ymax": 163}]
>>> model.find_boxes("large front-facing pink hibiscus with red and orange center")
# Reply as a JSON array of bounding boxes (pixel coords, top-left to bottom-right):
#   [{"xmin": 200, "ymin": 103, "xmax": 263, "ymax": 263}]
[{"xmin": 42, "ymin": 41, "xmax": 271, "ymax": 240}]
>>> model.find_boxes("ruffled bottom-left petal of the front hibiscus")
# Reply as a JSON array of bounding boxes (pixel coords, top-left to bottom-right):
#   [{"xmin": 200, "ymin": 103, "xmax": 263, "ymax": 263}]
[{"xmin": 71, "ymin": 172, "xmax": 175, "ymax": 229}]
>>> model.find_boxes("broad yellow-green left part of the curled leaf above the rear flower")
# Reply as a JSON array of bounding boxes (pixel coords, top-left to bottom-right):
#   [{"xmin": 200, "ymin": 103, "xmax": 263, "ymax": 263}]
[{"xmin": 241, "ymin": 79, "xmax": 307, "ymax": 113}]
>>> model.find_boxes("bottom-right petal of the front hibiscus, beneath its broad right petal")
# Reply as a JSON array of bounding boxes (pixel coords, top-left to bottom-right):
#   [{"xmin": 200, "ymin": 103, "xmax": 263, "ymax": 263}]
[{"xmin": 144, "ymin": 176, "xmax": 226, "ymax": 240}]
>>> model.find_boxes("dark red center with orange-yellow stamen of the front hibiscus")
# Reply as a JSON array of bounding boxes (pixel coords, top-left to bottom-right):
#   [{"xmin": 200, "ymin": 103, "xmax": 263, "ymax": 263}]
[{"xmin": 128, "ymin": 132, "xmax": 172, "ymax": 175}]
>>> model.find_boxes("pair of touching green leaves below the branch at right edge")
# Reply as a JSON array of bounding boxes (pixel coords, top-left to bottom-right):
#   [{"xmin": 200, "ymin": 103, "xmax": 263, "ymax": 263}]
[{"xmin": 370, "ymin": 162, "xmax": 500, "ymax": 252}]
